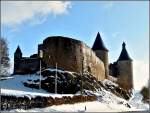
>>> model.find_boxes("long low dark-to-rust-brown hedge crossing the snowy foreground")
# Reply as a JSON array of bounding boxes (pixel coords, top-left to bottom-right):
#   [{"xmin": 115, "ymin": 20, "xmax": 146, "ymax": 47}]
[{"xmin": 1, "ymin": 95, "xmax": 96, "ymax": 110}]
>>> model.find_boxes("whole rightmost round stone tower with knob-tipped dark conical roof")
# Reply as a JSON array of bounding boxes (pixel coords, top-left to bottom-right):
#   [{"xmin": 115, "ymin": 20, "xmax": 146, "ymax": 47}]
[{"xmin": 117, "ymin": 42, "xmax": 133, "ymax": 90}]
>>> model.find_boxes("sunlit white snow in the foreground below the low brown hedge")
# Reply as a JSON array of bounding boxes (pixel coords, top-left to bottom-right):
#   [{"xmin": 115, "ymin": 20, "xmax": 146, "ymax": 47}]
[{"xmin": 6, "ymin": 92, "xmax": 148, "ymax": 112}]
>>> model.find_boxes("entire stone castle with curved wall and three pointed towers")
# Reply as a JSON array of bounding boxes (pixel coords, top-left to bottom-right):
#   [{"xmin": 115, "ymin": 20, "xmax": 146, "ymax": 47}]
[{"xmin": 14, "ymin": 32, "xmax": 133, "ymax": 90}]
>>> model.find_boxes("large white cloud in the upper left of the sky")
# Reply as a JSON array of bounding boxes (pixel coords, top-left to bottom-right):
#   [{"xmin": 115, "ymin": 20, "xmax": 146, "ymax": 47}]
[{"xmin": 1, "ymin": 1, "xmax": 71, "ymax": 26}]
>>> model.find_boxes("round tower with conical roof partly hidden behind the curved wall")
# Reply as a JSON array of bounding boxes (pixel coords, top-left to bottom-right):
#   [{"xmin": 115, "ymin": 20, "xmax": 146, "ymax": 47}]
[{"xmin": 92, "ymin": 32, "xmax": 108, "ymax": 77}]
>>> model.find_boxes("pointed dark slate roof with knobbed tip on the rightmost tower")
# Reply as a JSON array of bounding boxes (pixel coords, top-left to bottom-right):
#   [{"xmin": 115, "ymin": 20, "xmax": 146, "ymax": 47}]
[{"xmin": 118, "ymin": 42, "xmax": 132, "ymax": 61}]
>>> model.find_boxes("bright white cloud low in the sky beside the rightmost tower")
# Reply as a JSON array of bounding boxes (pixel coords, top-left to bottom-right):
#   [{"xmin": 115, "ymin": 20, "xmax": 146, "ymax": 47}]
[{"xmin": 133, "ymin": 60, "xmax": 149, "ymax": 90}]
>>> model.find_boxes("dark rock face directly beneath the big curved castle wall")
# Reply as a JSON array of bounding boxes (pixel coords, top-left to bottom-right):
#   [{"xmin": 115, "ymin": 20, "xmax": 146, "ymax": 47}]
[{"xmin": 24, "ymin": 69, "xmax": 101, "ymax": 94}]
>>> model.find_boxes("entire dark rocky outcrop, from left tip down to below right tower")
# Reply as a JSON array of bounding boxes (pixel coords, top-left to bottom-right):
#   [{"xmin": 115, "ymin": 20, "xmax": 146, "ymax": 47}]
[{"xmin": 24, "ymin": 69, "xmax": 132, "ymax": 100}]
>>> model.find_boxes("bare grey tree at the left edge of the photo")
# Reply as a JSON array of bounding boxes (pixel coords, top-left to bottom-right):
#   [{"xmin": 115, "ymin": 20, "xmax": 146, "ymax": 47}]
[{"xmin": 0, "ymin": 37, "xmax": 10, "ymax": 77}]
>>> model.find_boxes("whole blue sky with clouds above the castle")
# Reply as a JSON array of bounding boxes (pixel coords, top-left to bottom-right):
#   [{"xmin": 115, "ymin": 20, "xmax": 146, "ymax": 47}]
[{"xmin": 1, "ymin": 1, "xmax": 149, "ymax": 89}]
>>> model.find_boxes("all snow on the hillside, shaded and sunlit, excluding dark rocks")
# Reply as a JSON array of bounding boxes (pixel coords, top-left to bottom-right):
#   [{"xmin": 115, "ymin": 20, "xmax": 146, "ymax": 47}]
[{"xmin": 0, "ymin": 69, "xmax": 149, "ymax": 112}]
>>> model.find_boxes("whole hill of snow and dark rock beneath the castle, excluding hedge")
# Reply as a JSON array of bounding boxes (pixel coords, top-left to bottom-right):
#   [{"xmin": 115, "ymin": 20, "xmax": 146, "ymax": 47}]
[{"xmin": 0, "ymin": 69, "xmax": 149, "ymax": 112}]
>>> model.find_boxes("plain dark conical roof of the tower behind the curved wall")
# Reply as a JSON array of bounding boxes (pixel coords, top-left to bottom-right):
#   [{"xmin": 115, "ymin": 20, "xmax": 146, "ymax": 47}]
[{"xmin": 92, "ymin": 32, "xmax": 108, "ymax": 51}]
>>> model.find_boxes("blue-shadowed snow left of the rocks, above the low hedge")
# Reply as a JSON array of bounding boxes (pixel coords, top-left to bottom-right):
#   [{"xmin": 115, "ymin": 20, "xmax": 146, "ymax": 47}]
[{"xmin": 0, "ymin": 75, "xmax": 73, "ymax": 98}]
